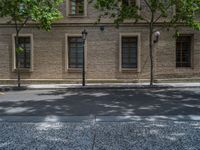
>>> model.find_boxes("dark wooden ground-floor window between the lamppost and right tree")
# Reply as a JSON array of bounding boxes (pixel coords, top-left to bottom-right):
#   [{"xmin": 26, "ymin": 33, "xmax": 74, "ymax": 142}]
[{"xmin": 122, "ymin": 37, "xmax": 138, "ymax": 69}]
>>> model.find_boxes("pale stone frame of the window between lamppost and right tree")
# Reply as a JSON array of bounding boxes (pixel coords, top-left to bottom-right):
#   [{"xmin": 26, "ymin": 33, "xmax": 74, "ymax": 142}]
[{"xmin": 119, "ymin": 33, "xmax": 141, "ymax": 73}]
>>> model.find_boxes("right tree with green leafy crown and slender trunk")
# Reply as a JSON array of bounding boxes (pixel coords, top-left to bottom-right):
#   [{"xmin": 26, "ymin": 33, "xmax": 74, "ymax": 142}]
[{"xmin": 95, "ymin": 0, "xmax": 200, "ymax": 86}]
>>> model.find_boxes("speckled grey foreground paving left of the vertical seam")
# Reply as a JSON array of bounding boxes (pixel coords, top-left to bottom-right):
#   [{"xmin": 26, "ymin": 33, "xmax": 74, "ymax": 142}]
[{"xmin": 0, "ymin": 122, "xmax": 93, "ymax": 150}]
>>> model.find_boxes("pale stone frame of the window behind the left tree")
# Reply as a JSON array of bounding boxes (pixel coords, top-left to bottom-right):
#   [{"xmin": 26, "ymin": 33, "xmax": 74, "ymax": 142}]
[{"xmin": 12, "ymin": 34, "xmax": 34, "ymax": 72}]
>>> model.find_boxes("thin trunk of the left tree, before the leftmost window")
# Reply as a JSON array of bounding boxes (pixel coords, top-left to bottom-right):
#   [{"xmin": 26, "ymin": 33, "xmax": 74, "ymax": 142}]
[{"xmin": 15, "ymin": 31, "xmax": 21, "ymax": 88}]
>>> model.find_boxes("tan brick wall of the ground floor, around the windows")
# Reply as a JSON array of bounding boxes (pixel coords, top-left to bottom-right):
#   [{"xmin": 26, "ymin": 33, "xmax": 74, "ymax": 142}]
[{"xmin": 0, "ymin": 26, "xmax": 200, "ymax": 82}]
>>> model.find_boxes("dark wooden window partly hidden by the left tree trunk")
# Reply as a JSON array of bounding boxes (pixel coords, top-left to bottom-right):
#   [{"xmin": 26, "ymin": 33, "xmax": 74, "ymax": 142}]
[{"xmin": 15, "ymin": 37, "xmax": 31, "ymax": 68}]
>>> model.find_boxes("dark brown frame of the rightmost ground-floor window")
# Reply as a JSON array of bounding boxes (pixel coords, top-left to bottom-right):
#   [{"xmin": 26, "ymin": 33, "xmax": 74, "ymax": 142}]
[{"xmin": 175, "ymin": 34, "xmax": 194, "ymax": 69}]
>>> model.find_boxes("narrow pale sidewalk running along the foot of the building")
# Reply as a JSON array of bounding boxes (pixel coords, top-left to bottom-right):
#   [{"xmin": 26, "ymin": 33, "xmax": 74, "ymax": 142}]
[{"xmin": 0, "ymin": 83, "xmax": 200, "ymax": 91}]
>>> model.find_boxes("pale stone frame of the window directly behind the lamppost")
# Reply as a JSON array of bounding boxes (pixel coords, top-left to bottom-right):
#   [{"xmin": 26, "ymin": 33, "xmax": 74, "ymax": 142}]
[{"xmin": 65, "ymin": 34, "xmax": 87, "ymax": 72}]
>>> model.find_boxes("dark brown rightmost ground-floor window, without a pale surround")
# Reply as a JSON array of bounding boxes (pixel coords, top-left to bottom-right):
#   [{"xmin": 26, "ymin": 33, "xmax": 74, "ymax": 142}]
[{"xmin": 176, "ymin": 36, "xmax": 192, "ymax": 67}]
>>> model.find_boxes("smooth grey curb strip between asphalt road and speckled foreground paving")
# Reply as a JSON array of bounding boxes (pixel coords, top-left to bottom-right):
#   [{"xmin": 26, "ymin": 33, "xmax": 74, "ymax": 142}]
[{"xmin": 0, "ymin": 115, "xmax": 200, "ymax": 123}]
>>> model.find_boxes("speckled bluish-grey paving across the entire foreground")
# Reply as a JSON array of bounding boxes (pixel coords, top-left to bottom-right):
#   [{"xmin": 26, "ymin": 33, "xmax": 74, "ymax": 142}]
[{"xmin": 0, "ymin": 120, "xmax": 200, "ymax": 150}]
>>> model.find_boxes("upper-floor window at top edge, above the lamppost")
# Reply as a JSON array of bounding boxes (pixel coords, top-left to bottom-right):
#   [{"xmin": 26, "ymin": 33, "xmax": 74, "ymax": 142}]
[{"xmin": 69, "ymin": 0, "xmax": 84, "ymax": 16}]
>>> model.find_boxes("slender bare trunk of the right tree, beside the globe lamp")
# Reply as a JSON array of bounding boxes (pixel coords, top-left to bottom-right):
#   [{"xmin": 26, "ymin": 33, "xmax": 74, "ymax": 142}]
[{"xmin": 149, "ymin": 23, "xmax": 154, "ymax": 86}]
